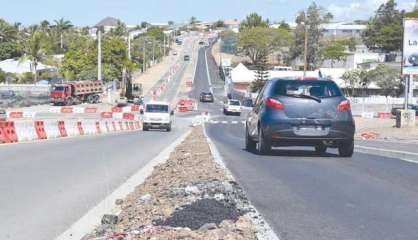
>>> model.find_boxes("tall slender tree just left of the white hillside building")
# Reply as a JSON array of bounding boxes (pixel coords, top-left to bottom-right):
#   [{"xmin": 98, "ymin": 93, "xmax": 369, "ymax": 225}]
[{"xmin": 290, "ymin": 2, "xmax": 333, "ymax": 70}]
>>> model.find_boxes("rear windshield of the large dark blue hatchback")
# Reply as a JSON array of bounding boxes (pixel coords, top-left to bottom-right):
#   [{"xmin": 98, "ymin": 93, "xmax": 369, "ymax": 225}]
[{"xmin": 272, "ymin": 80, "xmax": 342, "ymax": 98}]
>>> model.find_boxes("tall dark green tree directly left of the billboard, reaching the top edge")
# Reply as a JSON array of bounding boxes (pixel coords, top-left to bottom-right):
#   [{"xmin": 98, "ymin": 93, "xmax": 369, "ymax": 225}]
[{"xmin": 362, "ymin": 0, "xmax": 403, "ymax": 52}]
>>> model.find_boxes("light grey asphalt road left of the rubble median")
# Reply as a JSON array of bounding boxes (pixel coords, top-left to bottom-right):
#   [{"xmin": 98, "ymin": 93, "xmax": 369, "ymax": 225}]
[{"xmin": 0, "ymin": 37, "xmax": 198, "ymax": 240}]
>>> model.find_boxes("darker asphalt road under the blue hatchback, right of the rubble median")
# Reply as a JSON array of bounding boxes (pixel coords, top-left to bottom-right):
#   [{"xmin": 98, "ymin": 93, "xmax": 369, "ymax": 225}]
[{"xmin": 193, "ymin": 44, "xmax": 418, "ymax": 240}]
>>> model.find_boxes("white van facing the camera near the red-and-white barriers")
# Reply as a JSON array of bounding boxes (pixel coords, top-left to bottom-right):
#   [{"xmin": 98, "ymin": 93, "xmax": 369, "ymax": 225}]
[{"xmin": 141, "ymin": 102, "xmax": 174, "ymax": 132}]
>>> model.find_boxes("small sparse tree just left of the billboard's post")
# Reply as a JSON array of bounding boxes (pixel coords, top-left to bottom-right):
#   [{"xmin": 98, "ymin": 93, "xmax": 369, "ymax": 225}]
[{"xmin": 368, "ymin": 64, "xmax": 402, "ymax": 97}]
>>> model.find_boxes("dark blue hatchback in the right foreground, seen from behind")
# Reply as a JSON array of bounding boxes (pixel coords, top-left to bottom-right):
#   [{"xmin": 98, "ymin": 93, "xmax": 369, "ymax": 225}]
[{"xmin": 245, "ymin": 79, "xmax": 355, "ymax": 157}]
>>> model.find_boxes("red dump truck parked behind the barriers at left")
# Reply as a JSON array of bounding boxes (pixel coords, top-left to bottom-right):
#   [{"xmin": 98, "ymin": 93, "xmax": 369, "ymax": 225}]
[{"xmin": 50, "ymin": 81, "xmax": 103, "ymax": 106}]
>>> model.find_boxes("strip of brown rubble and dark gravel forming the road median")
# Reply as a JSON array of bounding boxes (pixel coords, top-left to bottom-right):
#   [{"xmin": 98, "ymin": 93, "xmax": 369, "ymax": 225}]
[{"xmin": 85, "ymin": 127, "xmax": 257, "ymax": 240}]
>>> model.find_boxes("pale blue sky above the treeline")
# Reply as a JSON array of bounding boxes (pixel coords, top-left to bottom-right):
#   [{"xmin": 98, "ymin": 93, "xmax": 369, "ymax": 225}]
[{"xmin": 0, "ymin": 0, "xmax": 415, "ymax": 26}]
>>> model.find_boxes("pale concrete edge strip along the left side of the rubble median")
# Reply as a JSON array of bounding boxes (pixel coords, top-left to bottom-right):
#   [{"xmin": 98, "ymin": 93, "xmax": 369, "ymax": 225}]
[{"xmin": 56, "ymin": 130, "xmax": 191, "ymax": 240}]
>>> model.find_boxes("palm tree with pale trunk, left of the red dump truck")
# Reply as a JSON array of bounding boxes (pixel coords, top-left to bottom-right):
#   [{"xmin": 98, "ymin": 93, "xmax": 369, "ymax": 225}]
[{"xmin": 21, "ymin": 30, "xmax": 46, "ymax": 83}]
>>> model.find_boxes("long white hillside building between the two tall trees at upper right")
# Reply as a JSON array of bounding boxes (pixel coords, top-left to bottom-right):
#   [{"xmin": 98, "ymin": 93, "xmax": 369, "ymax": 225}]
[{"xmin": 321, "ymin": 22, "xmax": 367, "ymax": 38}]
